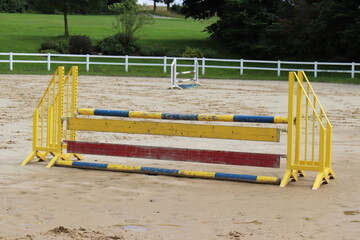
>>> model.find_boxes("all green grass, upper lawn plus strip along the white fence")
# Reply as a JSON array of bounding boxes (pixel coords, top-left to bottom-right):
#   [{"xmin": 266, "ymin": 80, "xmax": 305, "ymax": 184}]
[{"xmin": 0, "ymin": 13, "xmax": 360, "ymax": 83}]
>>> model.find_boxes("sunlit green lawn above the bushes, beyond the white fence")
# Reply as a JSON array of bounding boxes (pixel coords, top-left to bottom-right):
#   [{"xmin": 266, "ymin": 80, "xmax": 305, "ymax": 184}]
[{"xmin": 0, "ymin": 13, "xmax": 214, "ymax": 53}]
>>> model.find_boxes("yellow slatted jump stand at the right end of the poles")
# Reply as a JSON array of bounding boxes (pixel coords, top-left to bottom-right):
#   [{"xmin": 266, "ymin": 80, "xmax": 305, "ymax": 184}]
[{"xmin": 280, "ymin": 71, "xmax": 335, "ymax": 189}]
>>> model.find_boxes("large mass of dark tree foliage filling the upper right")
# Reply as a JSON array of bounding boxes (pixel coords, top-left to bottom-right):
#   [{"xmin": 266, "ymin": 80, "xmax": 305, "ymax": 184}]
[{"xmin": 184, "ymin": 0, "xmax": 360, "ymax": 61}]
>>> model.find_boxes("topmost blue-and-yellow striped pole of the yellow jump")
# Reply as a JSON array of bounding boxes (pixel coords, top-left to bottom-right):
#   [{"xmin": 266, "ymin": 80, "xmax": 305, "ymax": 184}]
[{"xmin": 78, "ymin": 108, "xmax": 288, "ymax": 123}]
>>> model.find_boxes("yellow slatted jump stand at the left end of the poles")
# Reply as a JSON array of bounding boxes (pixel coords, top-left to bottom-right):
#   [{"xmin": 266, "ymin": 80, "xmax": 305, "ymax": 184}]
[{"xmin": 21, "ymin": 66, "xmax": 81, "ymax": 167}]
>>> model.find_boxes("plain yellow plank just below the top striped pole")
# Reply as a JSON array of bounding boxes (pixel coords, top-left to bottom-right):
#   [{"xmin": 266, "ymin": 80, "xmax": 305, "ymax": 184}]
[{"xmin": 67, "ymin": 118, "xmax": 280, "ymax": 142}]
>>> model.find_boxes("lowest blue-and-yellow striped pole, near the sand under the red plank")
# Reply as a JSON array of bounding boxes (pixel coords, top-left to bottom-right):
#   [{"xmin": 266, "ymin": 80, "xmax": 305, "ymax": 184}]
[{"xmin": 56, "ymin": 160, "xmax": 280, "ymax": 184}]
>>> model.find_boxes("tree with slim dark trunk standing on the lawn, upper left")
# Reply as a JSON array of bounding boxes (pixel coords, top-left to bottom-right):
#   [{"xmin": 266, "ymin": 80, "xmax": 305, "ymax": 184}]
[{"xmin": 28, "ymin": 0, "xmax": 104, "ymax": 36}]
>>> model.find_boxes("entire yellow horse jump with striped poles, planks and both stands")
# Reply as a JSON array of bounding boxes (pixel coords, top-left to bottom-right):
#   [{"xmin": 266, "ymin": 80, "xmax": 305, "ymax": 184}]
[{"xmin": 22, "ymin": 67, "xmax": 335, "ymax": 189}]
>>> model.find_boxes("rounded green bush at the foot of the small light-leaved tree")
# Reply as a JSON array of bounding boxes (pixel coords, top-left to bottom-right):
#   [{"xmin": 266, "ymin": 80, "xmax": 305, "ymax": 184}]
[{"xmin": 96, "ymin": 33, "xmax": 140, "ymax": 55}]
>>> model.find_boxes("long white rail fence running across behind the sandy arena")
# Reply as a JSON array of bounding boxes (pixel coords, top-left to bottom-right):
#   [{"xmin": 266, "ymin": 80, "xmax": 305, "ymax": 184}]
[{"xmin": 0, "ymin": 52, "xmax": 360, "ymax": 78}]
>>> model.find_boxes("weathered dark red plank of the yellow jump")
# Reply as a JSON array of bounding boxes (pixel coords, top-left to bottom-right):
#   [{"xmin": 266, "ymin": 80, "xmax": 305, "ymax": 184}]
[{"xmin": 66, "ymin": 141, "xmax": 281, "ymax": 168}]
